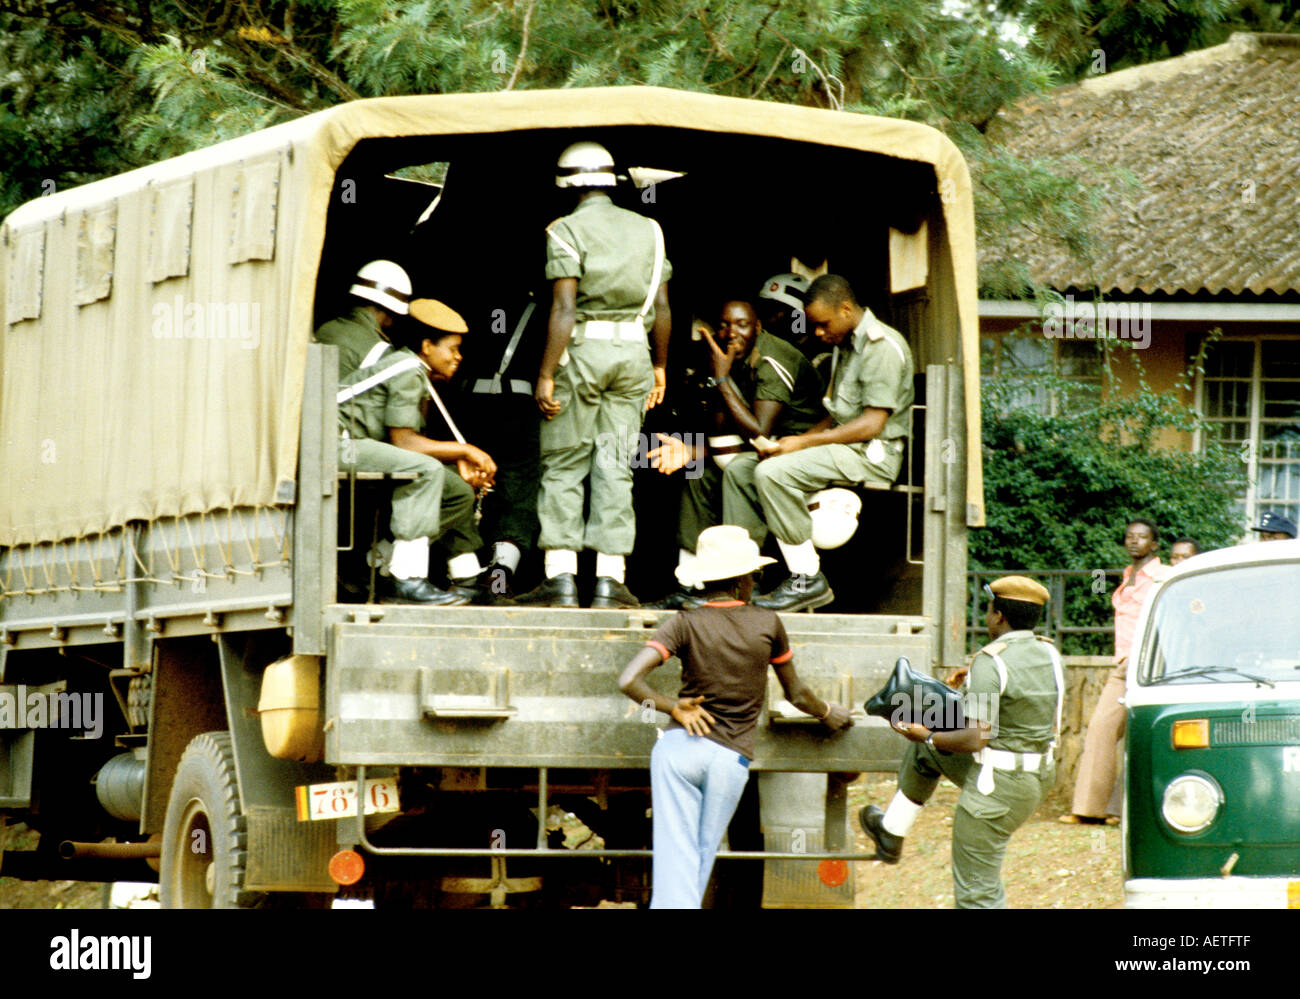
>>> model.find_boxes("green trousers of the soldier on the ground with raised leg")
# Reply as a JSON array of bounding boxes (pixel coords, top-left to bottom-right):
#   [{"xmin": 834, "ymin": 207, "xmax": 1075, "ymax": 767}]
[{"xmin": 898, "ymin": 743, "xmax": 1056, "ymax": 909}]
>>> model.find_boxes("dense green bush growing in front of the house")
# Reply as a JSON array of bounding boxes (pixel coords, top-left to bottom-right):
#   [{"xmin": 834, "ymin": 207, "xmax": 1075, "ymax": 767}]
[{"xmin": 970, "ymin": 353, "xmax": 1244, "ymax": 654}]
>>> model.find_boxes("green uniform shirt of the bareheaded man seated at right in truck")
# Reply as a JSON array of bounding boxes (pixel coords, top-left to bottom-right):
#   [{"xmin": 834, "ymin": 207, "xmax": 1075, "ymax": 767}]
[{"xmin": 827, "ymin": 308, "xmax": 914, "ymax": 441}]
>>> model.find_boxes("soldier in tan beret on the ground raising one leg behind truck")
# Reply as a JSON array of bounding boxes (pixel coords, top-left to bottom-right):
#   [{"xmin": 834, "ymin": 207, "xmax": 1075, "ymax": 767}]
[{"xmin": 858, "ymin": 576, "xmax": 1065, "ymax": 909}]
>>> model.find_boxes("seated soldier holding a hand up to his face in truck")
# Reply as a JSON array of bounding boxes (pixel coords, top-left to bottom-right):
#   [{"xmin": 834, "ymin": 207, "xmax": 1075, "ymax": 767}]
[{"xmin": 649, "ymin": 299, "xmax": 822, "ymax": 610}]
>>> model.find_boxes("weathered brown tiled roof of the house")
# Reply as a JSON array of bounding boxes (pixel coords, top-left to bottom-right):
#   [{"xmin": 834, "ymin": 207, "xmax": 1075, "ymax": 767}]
[{"xmin": 982, "ymin": 34, "xmax": 1300, "ymax": 297}]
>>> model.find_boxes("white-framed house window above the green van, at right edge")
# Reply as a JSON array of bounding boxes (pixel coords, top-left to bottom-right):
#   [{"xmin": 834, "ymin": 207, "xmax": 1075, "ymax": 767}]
[{"xmin": 1197, "ymin": 336, "xmax": 1300, "ymax": 526}]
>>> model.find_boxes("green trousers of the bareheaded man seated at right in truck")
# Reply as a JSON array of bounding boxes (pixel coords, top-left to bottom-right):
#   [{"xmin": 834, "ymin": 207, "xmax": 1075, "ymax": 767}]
[{"xmin": 723, "ymin": 444, "xmax": 902, "ymax": 548}]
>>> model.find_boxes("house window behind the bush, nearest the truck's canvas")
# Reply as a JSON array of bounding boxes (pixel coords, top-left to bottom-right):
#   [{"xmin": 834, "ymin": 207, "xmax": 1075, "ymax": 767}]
[{"xmin": 980, "ymin": 330, "xmax": 1106, "ymax": 416}]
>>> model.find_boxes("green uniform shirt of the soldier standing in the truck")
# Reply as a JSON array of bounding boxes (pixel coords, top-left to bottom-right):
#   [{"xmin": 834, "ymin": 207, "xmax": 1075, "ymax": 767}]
[{"xmin": 546, "ymin": 194, "xmax": 672, "ymax": 323}]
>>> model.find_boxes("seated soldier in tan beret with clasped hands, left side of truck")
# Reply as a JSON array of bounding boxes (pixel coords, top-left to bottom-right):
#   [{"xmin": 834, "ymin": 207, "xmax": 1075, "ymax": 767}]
[{"xmin": 330, "ymin": 293, "xmax": 497, "ymax": 606}]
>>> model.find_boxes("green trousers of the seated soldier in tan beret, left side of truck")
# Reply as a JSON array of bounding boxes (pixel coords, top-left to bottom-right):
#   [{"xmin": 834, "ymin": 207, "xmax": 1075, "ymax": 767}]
[{"xmin": 338, "ymin": 437, "xmax": 482, "ymax": 555}]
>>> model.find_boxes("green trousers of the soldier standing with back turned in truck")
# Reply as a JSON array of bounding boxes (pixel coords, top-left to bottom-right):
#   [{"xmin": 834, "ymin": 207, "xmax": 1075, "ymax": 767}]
[{"xmin": 537, "ymin": 340, "xmax": 654, "ymax": 555}]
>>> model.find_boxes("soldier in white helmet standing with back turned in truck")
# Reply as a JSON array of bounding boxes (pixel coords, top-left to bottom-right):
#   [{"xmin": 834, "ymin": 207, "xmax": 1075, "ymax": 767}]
[{"xmin": 517, "ymin": 142, "xmax": 672, "ymax": 607}]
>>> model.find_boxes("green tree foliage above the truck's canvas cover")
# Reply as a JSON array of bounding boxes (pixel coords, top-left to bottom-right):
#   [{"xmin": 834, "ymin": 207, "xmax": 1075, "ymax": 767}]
[{"xmin": 0, "ymin": 0, "xmax": 1300, "ymax": 222}]
